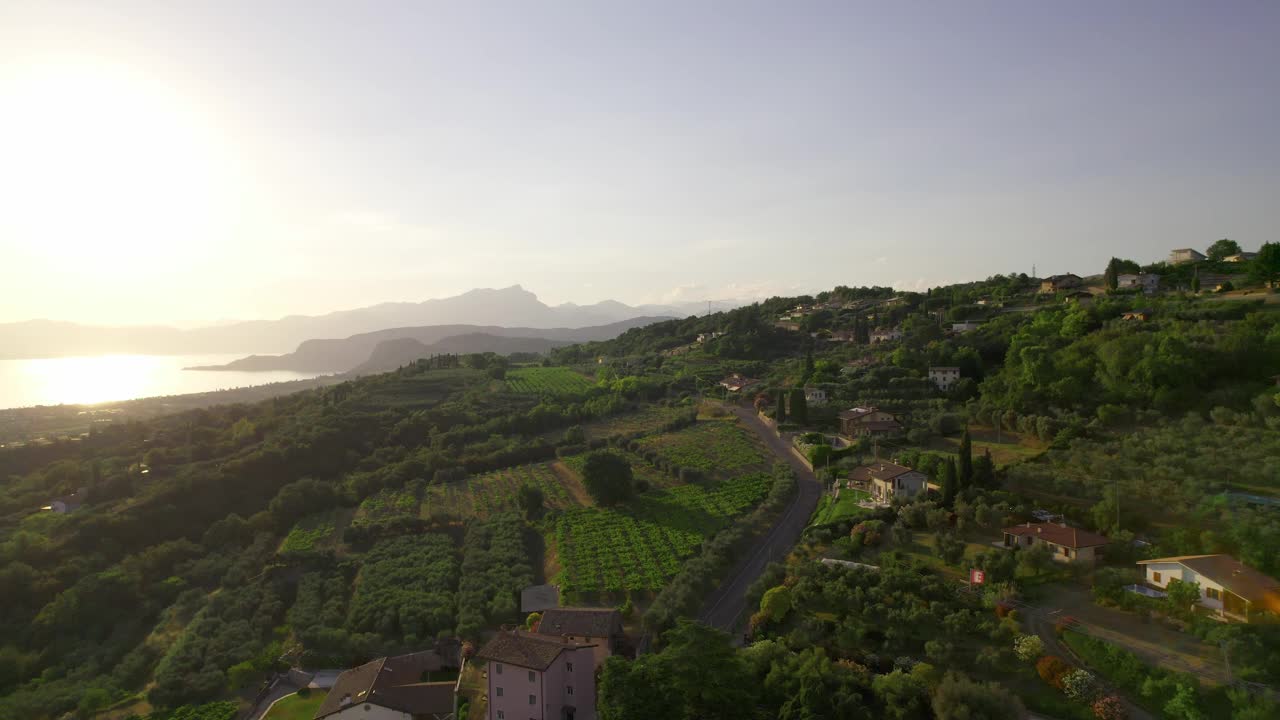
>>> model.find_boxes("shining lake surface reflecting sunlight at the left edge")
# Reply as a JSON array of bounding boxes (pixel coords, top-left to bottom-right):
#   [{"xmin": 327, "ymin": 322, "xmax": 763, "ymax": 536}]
[{"xmin": 0, "ymin": 355, "xmax": 320, "ymax": 409}]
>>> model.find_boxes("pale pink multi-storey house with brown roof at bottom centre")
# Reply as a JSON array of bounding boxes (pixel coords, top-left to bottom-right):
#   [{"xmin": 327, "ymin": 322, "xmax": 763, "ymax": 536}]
[{"xmin": 476, "ymin": 630, "xmax": 595, "ymax": 720}]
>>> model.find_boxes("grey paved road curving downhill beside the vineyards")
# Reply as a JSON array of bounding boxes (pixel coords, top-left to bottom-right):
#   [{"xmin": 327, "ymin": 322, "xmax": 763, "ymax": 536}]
[{"xmin": 698, "ymin": 407, "xmax": 822, "ymax": 630}]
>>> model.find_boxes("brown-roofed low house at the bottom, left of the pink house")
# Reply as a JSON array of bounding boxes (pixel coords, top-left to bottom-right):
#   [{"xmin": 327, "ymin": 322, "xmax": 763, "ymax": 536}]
[{"xmin": 314, "ymin": 651, "xmax": 456, "ymax": 720}]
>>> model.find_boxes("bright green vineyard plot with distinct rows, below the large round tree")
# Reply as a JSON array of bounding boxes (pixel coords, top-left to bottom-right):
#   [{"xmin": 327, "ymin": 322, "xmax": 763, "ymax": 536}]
[{"xmin": 554, "ymin": 473, "xmax": 772, "ymax": 592}]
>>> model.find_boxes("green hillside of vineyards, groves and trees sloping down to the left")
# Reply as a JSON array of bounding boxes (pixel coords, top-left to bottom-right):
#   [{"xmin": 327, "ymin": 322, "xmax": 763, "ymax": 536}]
[{"xmin": 0, "ymin": 265, "xmax": 1280, "ymax": 719}]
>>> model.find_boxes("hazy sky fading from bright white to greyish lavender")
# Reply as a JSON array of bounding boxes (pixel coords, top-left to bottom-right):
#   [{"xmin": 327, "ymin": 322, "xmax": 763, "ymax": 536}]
[{"xmin": 0, "ymin": 0, "xmax": 1280, "ymax": 324}]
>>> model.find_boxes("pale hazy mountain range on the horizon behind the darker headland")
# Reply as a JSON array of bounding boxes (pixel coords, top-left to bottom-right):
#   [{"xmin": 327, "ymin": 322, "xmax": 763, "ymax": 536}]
[{"xmin": 0, "ymin": 284, "xmax": 724, "ymax": 358}]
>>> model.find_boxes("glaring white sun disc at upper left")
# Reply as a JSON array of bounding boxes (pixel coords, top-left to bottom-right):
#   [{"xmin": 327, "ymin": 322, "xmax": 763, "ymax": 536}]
[{"xmin": 0, "ymin": 58, "xmax": 230, "ymax": 274}]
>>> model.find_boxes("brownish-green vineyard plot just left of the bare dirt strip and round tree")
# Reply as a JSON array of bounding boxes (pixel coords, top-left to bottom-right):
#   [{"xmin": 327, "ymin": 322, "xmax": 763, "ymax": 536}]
[{"xmin": 420, "ymin": 462, "xmax": 577, "ymax": 518}]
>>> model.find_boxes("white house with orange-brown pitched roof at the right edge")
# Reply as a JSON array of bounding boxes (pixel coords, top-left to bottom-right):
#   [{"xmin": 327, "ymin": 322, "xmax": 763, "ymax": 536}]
[{"xmin": 1138, "ymin": 555, "xmax": 1280, "ymax": 623}]
